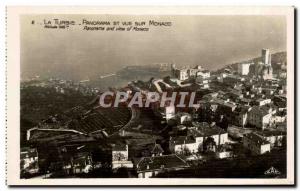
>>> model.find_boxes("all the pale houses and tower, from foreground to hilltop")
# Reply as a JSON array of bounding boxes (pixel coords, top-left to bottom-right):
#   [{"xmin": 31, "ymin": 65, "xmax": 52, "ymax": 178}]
[{"xmin": 21, "ymin": 49, "xmax": 287, "ymax": 178}]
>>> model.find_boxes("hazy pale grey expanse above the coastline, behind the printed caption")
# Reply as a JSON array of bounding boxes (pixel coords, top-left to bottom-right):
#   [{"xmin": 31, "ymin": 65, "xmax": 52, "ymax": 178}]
[{"xmin": 20, "ymin": 15, "xmax": 286, "ymax": 80}]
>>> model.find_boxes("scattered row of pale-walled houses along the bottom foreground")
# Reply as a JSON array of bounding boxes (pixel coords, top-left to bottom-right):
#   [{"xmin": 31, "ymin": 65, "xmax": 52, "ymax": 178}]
[{"xmin": 21, "ymin": 122, "xmax": 286, "ymax": 178}]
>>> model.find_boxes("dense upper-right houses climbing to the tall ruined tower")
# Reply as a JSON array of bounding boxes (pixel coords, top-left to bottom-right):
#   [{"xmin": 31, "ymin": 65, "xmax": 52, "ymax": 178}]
[{"xmin": 162, "ymin": 49, "xmax": 286, "ymax": 130}]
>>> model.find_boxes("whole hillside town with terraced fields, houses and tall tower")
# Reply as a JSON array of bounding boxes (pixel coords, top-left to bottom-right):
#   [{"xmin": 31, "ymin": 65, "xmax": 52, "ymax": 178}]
[{"xmin": 20, "ymin": 49, "xmax": 292, "ymax": 178}]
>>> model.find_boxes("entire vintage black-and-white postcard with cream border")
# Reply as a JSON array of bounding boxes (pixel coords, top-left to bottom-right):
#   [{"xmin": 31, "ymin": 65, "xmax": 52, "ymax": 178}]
[{"xmin": 6, "ymin": 7, "xmax": 295, "ymax": 186}]
